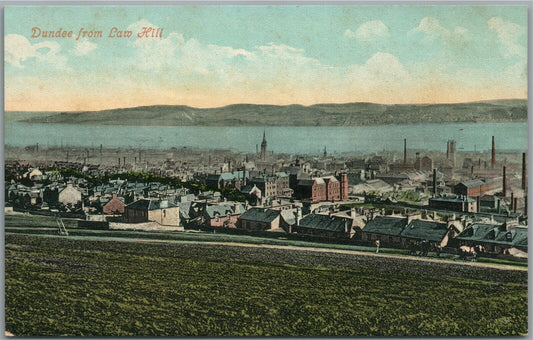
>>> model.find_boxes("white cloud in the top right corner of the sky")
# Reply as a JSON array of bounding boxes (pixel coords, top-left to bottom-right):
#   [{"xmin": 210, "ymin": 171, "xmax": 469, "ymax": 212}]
[{"xmin": 487, "ymin": 17, "xmax": 526, "ymax": 57}]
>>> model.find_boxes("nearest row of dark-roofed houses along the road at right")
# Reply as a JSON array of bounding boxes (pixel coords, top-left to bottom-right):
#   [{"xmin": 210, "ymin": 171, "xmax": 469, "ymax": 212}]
[{"xmin": 237, "ymin": 208, "xmax": 527, "ymax": 256}]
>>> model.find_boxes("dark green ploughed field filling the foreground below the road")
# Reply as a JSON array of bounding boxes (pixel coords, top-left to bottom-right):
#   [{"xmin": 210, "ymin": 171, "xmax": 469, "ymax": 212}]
[{"xmin": 5, "ymin": 234, "xmax": 528, "ymax": 336}]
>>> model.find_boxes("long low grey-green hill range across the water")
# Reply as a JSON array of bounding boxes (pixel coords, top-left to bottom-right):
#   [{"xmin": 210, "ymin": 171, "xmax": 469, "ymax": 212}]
[{"xmin": 5, "ymin": 99, "xmax": 527, "ymax": 126}]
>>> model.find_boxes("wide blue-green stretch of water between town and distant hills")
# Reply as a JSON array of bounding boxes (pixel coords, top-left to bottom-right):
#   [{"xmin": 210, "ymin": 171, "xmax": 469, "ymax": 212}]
[{"xmin": 5, "ymin": 122, "xmax": 528, "ymax": 154}]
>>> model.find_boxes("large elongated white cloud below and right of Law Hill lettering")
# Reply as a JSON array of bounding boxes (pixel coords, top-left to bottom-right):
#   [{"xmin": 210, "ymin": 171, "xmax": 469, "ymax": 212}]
[{"xmin": 128, "ymin": 19, "xmax": 319, "ymax": 82}]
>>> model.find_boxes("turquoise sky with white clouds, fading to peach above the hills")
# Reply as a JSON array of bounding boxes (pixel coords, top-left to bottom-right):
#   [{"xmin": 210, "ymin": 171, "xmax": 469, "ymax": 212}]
[{"xmin": 4, "ymin": 5, "xmax": 528, "ymax": 111}]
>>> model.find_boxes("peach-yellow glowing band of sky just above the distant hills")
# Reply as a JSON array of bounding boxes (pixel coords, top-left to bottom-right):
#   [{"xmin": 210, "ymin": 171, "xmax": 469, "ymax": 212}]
[{"xmin": 4, "ymin": 86, "xmax": 527, "ymax": 112}]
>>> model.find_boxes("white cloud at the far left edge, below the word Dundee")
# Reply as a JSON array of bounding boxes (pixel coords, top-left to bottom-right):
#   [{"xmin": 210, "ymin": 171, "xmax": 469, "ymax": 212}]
[{"xmin": 4, "ymin": 34, "xmax": 70, "ymax": 70}]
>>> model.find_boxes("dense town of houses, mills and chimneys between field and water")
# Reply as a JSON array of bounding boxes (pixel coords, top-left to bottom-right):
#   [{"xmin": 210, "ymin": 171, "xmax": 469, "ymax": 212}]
[{"xmin": 5, "ymin": 134, "xmax": 527, "ymax": 253}]
